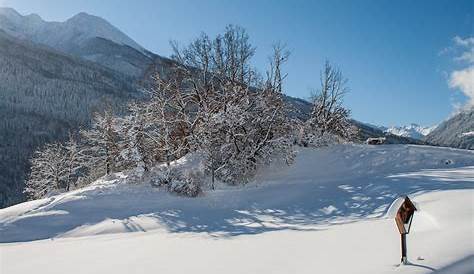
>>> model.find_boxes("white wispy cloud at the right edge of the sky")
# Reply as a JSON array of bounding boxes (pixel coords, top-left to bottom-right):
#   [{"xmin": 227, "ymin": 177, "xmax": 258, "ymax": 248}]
[{"xmin": 448, "ymin": 36, "xmax": 474, "ymax": 108}]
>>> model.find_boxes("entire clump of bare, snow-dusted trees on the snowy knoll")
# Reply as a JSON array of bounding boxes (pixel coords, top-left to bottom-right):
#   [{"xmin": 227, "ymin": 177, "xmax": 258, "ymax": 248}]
[{"xmin": 26, "ymin": 26, "xmax": 349, "ymax": 198}]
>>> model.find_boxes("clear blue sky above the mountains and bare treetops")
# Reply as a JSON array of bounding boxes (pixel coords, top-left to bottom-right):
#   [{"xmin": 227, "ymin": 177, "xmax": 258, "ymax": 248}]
[{"xmin": 0, "ymin": 0, "xmax": 474, "ymax": 126}]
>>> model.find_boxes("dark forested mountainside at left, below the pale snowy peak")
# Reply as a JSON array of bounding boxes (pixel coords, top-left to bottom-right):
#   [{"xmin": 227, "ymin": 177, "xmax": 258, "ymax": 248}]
[{"xmin": 0, "ymin": 29, "xmax": 142, "ymax": 207}]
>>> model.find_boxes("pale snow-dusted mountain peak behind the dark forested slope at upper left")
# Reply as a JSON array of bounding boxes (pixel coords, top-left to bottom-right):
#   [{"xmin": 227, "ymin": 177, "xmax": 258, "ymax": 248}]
[{"xmin": 0, "ymin": 8, "xmax": 158, "ymax": 78}]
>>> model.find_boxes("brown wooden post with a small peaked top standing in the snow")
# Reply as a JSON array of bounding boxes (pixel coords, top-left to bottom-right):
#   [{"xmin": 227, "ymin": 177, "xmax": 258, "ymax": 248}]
[{"xmin": 395, "ymin": 196, "xmax": 416, "ymax": 264}]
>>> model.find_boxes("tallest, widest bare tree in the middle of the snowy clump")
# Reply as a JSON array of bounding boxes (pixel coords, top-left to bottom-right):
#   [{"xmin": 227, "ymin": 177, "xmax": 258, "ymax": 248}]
[{"xmin": 169, "ymin": 26, "xmax": 291, "ymax": 183}]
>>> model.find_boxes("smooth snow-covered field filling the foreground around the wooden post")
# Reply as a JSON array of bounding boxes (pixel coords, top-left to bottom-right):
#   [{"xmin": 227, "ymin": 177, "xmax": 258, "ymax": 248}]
[{"xmin": 0, "ymin": 145, "xmax": 474, "ymax": 274}]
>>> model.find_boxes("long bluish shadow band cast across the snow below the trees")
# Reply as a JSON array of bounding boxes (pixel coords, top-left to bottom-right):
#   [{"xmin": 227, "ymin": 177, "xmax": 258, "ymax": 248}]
[{"xmin": 0, "ymin": 167, "xmax": 474, "ymax": 242}]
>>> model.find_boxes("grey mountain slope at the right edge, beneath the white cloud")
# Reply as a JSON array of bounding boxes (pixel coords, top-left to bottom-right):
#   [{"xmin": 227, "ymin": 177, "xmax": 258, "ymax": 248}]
[{"xmin": 425, "ymin": 108, "xmax": 474, "ymax": 150}]
